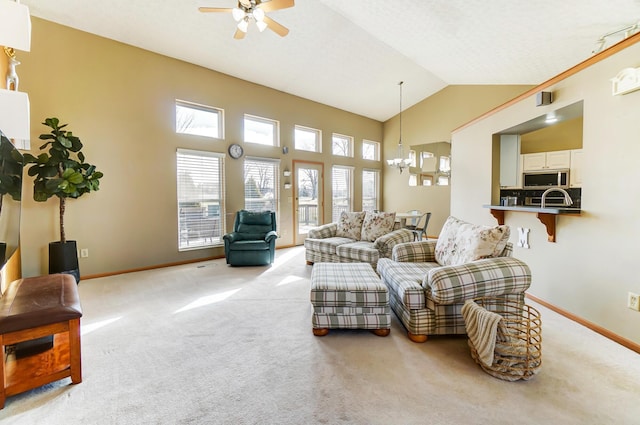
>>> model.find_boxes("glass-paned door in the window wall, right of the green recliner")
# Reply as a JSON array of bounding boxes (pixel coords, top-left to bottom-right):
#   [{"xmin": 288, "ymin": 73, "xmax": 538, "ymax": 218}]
[{"xmin": 293, "ymin": 161, "xmax": 324, "ymax": 245}]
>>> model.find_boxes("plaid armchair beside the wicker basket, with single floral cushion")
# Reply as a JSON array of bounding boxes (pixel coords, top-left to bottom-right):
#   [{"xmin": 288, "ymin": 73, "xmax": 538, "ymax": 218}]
[{"xmin": 377, "ymin": 240, "xmax": 531, "ymax": 342}]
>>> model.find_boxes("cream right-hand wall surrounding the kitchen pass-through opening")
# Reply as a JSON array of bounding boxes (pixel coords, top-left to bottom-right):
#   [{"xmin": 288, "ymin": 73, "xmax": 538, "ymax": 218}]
[{"xmin": 451, "ymin": 36, "xmax": 640, "ymax": 343}]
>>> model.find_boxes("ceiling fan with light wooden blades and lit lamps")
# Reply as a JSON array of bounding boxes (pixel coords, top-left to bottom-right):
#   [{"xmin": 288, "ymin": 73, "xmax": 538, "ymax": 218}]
[{"xmin": 198, "ymin": 0, "xmax": 294, "ymax": 40}]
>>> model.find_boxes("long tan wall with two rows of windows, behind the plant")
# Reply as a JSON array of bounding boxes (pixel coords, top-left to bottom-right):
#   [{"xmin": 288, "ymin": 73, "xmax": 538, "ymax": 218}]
[{"xmin": 20, "ymin": 18, "xmax": 382, "ymax": 276}]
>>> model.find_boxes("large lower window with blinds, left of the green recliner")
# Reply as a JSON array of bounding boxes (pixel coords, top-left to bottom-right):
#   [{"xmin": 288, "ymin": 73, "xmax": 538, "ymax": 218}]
[{"xmin": 176, "ymin": 149, "xmax": 225, "ymax": 251}]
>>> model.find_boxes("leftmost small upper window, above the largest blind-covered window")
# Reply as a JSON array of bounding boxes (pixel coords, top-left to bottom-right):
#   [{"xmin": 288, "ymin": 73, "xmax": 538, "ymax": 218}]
[{"xmin": 176, "ymin": 100, "xmax": 224, "ymax": 139}]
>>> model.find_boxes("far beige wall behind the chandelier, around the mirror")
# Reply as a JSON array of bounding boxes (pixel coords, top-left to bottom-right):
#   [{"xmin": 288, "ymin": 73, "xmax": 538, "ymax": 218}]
[{"xmin": 383, "ymin": 86, "xmax": 531, "ymax": 236}]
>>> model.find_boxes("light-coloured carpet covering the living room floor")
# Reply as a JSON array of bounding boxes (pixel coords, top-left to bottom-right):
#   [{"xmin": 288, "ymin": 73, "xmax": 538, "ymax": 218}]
[{"xmin": 0, "ymin": 248, "xmax": 640, "ymax": 425}]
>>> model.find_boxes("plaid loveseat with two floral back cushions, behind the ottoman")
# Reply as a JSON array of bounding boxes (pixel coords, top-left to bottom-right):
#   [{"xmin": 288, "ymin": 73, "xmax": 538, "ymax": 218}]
[{"xmin": 304, "ymin": 223, "xmax": 414, "ymax": 270}]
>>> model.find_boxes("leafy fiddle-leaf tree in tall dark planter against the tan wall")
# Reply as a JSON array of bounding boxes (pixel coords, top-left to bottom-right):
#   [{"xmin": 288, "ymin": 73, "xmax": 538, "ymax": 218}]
[{"xmin": 24, "ymin": 118, "xmax": 103, "ymax": 282}]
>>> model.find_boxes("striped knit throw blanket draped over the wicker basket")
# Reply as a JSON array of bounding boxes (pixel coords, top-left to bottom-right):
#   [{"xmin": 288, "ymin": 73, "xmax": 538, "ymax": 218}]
[{"xmin": 461, "ymin": 300, "xmax": 502, "ymax": 366}]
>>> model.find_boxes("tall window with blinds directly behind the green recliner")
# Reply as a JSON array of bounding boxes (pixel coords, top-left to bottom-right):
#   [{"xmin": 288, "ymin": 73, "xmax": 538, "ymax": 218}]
[{"xmin": 244, "ymin": 158, "xmax": 280, "ymax": 216}]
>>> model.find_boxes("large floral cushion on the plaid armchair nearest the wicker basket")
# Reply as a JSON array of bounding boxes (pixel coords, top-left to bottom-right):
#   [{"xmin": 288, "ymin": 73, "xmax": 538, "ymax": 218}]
[{"xmin": 435, "ymin": 216, "xmax": 511, "ymax": 266}]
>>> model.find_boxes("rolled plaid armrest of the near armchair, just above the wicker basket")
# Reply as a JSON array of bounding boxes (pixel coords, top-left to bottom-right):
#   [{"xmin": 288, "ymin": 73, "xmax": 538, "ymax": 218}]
[{"xmin": 422, "ymin": 257, "xmax": 531, "ymax": 304}]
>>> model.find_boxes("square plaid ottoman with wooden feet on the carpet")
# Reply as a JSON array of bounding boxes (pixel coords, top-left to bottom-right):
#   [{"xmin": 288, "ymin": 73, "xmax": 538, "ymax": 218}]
[{"xmin": 311, "ymin": 263, "xmax": 391, "ymax": 336}]
